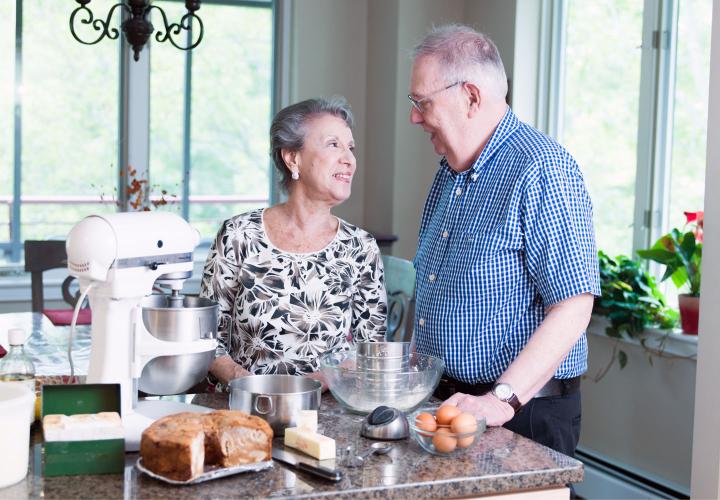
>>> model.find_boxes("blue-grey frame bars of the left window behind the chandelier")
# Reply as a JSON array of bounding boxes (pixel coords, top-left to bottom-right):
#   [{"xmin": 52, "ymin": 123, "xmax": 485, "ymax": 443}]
[{"xmin": 0, "ymin": 0, "xmax": 276, "ymax": 267}]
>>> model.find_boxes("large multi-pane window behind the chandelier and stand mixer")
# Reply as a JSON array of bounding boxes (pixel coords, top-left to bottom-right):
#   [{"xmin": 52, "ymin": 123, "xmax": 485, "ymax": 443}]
[{"xmin": 0, "ymin": 0, "xmax": 273, "ymax": 264}]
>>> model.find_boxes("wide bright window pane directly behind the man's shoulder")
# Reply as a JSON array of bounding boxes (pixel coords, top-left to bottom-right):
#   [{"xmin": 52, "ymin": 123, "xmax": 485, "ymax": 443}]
[{"xmin": 562, "ymin": 0, "xmax": 643, "ymax": 255}]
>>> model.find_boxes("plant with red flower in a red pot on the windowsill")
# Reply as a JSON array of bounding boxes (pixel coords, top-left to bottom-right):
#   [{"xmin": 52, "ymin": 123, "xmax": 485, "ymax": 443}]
[{"xmin": 638, "ymin": 212, "xmax": 703, "ymax": 335}]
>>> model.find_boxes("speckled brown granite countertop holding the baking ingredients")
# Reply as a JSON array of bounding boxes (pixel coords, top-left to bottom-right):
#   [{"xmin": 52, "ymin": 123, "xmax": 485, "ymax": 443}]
[{"xmin": 0, "ymin": 394, "xmax": 583, "ymax": 500}]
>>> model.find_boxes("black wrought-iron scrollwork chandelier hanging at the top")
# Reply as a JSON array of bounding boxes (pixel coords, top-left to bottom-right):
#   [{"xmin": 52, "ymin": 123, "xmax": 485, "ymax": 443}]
[{"xmin": 70, "ymin": 0, "xmax": 204, "ymax": 61}]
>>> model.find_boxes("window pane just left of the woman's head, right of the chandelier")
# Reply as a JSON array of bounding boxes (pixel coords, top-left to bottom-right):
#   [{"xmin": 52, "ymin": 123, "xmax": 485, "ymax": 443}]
[{"xmin": 190, "ymin": 5, "xmax": 272, "ymax": 237}]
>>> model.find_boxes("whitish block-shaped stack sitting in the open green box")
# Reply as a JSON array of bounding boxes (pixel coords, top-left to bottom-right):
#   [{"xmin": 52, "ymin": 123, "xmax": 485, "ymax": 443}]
[{"xmin": 43, "ymin": 412, "xmax": 125, "ymax": 442}]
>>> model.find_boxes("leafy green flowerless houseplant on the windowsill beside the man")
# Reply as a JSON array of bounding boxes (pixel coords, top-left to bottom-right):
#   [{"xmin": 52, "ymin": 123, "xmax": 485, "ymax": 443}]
[{"xmin": 595, "ymin": 251, "xmax": 679, "ymax": 368}]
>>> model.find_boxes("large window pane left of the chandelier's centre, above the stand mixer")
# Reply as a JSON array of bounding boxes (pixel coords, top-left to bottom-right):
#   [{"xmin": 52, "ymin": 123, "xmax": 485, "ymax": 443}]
[{"xmin": 21, "ymin": 0, "xmax": 118, "ymax": 239}]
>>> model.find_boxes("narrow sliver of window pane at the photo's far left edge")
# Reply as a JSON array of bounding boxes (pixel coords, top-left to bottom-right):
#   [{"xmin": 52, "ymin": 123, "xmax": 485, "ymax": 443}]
[{"xmin": 0, "ymin": 1, "xmax": 15, "ymax": 250}]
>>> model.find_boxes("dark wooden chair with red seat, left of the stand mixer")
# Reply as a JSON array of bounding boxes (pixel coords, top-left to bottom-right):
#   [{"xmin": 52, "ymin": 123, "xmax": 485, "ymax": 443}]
[{"xmin": 25, "ymin": 240, "xmax": 91, "ymax": 325}]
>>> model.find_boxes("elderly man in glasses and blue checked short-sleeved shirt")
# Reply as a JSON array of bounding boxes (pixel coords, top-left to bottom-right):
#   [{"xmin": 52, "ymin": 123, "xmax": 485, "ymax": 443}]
[{"xmin": 408, "ymin": 25, "xmax": 600, "ymax": 455}]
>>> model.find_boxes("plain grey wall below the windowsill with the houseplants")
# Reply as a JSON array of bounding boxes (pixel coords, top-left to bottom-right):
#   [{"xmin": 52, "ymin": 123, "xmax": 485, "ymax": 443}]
[{"xmin": 579, "ymin": 318, "xmax": 697, "ymax": 493}]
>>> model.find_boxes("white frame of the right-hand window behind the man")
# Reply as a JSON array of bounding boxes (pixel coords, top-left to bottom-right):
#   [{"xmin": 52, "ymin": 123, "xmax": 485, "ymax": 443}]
[{"xmin": 537, "ymin": 0, "xmax": 679, "ymax": 255}]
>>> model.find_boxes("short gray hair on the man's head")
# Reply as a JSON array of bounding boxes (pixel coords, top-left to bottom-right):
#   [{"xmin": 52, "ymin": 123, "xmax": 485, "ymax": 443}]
[{"xmin": 412, "ymin": 24, "xmax": 507, "ymax": 100}]
